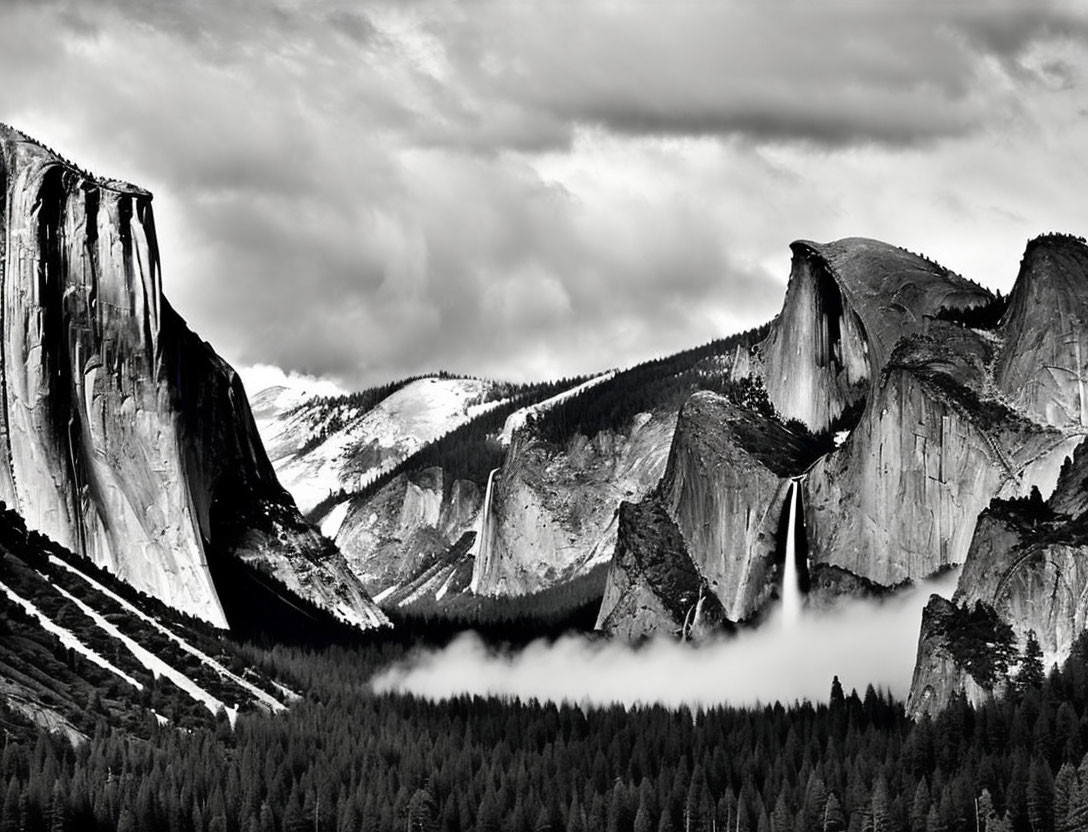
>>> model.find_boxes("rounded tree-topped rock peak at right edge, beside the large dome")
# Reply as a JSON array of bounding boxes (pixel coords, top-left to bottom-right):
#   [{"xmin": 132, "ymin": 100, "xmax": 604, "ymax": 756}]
[{"xmin": 996, "ymin": 236, "xmax": 1088, "ymax": 427}]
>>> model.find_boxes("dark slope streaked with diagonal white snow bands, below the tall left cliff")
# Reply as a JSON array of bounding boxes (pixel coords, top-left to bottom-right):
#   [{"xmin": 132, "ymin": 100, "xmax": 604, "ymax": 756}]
[{"xmin": 0, "ymin": 507, "xmax": 296, "ymax": 726}]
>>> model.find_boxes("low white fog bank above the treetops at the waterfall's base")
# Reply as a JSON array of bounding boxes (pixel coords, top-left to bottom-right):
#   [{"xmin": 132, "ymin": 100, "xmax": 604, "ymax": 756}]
[{"xmin": 371, "ymin": 572, "xmax": 959, "ymax": 708}]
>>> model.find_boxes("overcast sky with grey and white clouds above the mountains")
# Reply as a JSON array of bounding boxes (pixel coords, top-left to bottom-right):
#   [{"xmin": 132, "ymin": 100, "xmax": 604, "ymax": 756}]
[{"xmin": 0, "ymin": 0, "xmax": 1088, "ymax": 387}]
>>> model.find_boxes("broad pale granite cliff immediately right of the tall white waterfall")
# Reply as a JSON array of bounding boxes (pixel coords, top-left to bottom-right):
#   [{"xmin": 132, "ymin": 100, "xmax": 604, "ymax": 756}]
[{"xmin": 805, "ymin": 322, "xmax": 1079, "ymax": 586}]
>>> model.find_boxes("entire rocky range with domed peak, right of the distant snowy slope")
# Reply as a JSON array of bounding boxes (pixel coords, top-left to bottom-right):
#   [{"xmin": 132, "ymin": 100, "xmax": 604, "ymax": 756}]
[{"xmin": 254, "ymin": 235, "xmax": 1088, "ymax": 712}]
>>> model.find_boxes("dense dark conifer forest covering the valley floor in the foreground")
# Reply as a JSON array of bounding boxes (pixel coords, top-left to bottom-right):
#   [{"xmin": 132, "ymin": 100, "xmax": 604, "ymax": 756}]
[{"xmin": 6, "ymin": 617, "xmax": 1088, "ymax": 832}]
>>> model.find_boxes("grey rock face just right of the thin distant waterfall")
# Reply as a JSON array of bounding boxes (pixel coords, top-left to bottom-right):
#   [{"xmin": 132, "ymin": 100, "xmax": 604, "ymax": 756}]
[{"xmin": 472, "ymin": 413, "xmax": 676, "ymax": 596}]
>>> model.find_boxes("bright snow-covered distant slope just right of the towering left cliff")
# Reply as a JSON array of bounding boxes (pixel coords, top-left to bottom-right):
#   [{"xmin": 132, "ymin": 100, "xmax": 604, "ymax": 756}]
[{"xmin": 254, "ymin": 376, "xmax": 498, "ymax": 511}]
